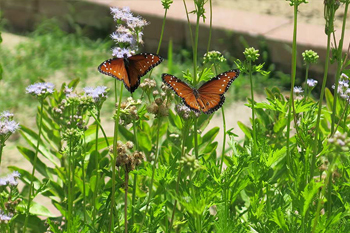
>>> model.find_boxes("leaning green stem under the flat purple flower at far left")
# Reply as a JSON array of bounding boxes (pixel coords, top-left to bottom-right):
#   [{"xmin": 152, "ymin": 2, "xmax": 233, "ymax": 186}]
[{"xmin": 23, "ymin": 100, "xmax": 44, "ymax": 233}]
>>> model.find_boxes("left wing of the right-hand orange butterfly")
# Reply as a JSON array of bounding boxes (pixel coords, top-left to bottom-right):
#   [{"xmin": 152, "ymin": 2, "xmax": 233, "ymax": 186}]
[{"xmin": 162, "ymin": 74, "xmax": 200, "ymax": 112}]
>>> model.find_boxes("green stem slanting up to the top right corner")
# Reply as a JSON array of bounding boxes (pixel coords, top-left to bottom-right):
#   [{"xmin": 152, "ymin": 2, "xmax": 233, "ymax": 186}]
[{"xmin": 331, "ymin": 1, "xmax": 350, "ymax": 134}]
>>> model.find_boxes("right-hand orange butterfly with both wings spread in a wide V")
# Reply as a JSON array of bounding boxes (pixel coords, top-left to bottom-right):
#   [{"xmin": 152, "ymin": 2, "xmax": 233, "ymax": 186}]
[{"xmin": 162, "ymin": 69, "xmax": 239, "ymax": 114}]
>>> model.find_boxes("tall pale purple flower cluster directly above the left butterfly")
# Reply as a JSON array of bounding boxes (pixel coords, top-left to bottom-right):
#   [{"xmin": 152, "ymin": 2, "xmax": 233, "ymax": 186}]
[{"xmin": 111, "ymin": 7, "xmax": 148, "ymax": 58}]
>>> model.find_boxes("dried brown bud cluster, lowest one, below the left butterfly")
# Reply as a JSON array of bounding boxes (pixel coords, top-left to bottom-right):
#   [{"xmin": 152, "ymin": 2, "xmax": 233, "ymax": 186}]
[{"xmin": 111, "ymin": 141, "xmax": 145, "ymax": 172}]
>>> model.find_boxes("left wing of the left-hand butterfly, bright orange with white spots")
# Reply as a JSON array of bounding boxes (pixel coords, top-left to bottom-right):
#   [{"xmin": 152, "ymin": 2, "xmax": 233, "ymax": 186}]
[{"xmin": 98, "ymin": 58, "xmax": 130, "ymax": 90}]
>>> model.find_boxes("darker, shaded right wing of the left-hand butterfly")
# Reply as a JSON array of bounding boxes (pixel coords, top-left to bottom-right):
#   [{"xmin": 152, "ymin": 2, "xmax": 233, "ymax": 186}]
[{"xmin": 126, "ymin": 53, "xmax": 163, "ymax": 92}]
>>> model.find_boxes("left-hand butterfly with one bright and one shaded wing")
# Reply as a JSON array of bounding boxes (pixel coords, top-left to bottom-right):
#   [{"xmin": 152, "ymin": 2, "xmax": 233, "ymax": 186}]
[{"xmin": 98, "ymin": 53, "xmax": 163, "ymax": 93}]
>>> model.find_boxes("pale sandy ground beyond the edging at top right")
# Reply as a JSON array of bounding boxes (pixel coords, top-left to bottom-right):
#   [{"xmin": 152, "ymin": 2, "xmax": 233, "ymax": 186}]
[{"xmin": 213, "ymin": 0, "xmax": 350, "ymax": 28}]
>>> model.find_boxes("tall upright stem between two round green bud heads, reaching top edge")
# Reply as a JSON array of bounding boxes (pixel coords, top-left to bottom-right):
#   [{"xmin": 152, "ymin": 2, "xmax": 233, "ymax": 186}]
[{"xmin": 287, "ymin": 3, "xmax": 298, "ymax": 169}]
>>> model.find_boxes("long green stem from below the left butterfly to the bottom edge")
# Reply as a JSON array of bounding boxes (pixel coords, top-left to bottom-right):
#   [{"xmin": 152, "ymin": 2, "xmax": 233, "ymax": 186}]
[{"xmin": 108, "ymin": 80, "xmax": 124, "ymax": 232}]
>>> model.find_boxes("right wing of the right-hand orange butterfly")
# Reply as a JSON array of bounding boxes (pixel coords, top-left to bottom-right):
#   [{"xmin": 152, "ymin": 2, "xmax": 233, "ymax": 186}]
[{"xmin": 197, "ymin": 70, "xmax": 239, "ymax": 114}]
